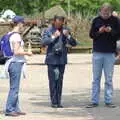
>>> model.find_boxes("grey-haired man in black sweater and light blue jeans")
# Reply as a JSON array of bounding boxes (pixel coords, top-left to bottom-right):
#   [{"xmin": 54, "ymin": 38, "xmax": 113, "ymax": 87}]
[{"xmin": 87, "ymin": 3, "xmax": 120, "ymax": 108}]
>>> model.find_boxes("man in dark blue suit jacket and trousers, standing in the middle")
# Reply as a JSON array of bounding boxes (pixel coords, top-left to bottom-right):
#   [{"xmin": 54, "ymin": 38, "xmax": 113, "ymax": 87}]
[{"xmin": 42, "ymin": 16, "xmax": 76, "ymax": 108}]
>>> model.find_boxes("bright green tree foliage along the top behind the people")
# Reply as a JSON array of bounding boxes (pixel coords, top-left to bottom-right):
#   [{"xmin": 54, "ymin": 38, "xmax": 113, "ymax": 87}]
[{"xmin": 0, "ymin": 0, "xmax": 120, "ymax": 15}]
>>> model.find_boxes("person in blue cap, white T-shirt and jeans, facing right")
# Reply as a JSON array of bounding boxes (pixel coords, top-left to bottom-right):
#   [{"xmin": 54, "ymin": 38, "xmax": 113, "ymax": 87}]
[{"xmin": 5, "ymin": 16, "xmax": 32, "ymax": 117}]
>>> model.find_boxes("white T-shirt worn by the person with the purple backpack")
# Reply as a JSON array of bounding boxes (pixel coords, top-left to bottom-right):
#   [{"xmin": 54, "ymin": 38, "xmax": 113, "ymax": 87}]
[{"xmin": 8, "ymin": 32, "xmax": 26, "ymax": 62}]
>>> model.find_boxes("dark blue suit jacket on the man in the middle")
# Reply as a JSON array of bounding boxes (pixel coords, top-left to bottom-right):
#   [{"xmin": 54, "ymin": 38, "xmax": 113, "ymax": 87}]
[{"xmin": 42, "ymin": 26, "xmax": 77, "ymax": 65}]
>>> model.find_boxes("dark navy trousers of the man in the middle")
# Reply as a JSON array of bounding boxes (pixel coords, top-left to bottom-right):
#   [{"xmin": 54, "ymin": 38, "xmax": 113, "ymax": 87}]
[{"xmin": 48, "ymin": 64, "xmax": 65, "ymax": 105}]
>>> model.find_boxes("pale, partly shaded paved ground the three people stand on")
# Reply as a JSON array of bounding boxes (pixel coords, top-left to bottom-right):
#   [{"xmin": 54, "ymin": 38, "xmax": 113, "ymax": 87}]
[{"xmin": 0, "ymin": 54, "xmax": 120, "ymax": 120}]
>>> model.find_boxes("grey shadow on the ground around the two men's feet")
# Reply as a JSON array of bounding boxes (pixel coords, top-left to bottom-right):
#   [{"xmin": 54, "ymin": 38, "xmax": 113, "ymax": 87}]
[{"xmin": 30, "ymin": 89, "xmax": 120, "ymax": 120}]
